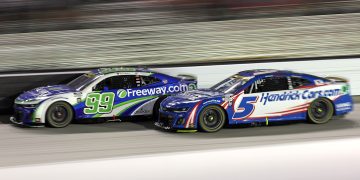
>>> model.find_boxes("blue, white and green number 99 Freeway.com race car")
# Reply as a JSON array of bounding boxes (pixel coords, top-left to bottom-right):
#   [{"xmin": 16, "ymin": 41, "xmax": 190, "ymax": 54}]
[{"xmin": 10, "ymin": 68, "xmax": 197, "ymax": 128}]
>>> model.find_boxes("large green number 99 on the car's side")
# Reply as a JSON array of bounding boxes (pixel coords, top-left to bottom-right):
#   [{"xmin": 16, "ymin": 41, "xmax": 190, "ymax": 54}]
[{"xmin": 84, "ymin": 92, "xmax": 115, "ymax": 114}]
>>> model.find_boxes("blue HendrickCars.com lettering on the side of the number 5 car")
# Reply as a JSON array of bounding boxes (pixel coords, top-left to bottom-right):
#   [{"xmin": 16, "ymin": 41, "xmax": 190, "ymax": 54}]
[{"xmin": 260, "ymin": 89, "xmax": 342, "ymax": 105}]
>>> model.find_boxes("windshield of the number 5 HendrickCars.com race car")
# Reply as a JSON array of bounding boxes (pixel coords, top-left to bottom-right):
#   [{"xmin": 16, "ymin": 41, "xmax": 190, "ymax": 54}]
[{"xmin": 210, "ymin": 75, "xmax": 248, "ymax": 93}]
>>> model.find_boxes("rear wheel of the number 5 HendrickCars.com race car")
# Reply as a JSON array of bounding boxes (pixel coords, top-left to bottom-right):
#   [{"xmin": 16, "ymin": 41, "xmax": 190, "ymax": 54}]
[{"xmin": 308, "ymin": 98, "xmax": 334, "ymax": 124}]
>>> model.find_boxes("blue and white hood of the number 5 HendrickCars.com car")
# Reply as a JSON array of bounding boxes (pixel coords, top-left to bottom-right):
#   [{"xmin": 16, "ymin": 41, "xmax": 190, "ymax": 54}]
[{"xmin": 162, "ymin": 89, "xmax": 225, "ymax": 108}]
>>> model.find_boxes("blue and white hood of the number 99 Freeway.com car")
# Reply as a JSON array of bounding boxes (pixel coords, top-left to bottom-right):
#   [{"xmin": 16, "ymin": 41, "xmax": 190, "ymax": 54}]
[{"xmin": 16, "ymin": 85, "xmax": 76, "ymax": 101}]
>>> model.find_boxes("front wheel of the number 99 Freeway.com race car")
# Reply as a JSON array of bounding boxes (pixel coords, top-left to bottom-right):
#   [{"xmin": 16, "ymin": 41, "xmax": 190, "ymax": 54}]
[{"xmin": 46, "ymin": 102, "xmax": 73, "ymax": 128}]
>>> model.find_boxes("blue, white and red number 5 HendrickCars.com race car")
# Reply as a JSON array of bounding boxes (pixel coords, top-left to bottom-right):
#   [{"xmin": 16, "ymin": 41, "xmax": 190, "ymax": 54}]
[{"xmin": 155, "ymin": 69, "xmax": 353, "ymax": 132}]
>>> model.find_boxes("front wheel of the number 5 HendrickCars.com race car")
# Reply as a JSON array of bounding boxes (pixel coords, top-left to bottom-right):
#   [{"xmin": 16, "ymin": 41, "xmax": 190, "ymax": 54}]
[{"xmin": 199, "ymin": 105, "xmax": 226, "ymax": 132}]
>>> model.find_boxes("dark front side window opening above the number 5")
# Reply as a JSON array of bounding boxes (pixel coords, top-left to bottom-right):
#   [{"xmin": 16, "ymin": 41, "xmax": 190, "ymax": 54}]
[{"xmin": 245, "ymin": 77, "xmax": 289, "ymax": 94}]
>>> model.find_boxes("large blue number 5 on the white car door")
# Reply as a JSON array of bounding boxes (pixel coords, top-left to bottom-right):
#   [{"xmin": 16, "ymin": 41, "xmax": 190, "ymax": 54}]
[{"xmin": 233, "ymin": 96, "xmax": 258, "ymax": 120}]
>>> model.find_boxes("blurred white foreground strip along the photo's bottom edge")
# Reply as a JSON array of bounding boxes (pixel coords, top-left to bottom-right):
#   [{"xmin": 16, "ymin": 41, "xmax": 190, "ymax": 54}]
[{"xmin": 0, "ymin": 138, "xmax": 360, "ymax": 180}]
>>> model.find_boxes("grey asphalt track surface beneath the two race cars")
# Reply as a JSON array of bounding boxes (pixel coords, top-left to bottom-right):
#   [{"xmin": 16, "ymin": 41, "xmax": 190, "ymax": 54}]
[{"xmin": 0, "ymin": 105, "xmax": 360, "ymax": 167}]
